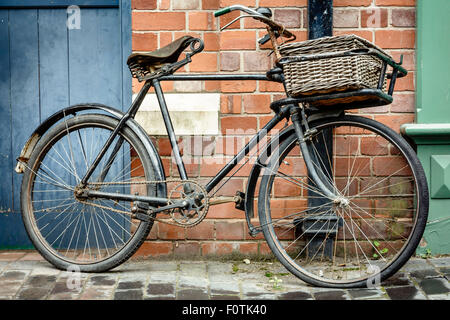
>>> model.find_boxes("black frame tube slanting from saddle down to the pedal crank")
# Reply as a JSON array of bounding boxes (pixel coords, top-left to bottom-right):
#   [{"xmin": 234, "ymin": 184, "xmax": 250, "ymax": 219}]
[{"xmin": 152, "ymin": 79, "xmax": 188, "ymax": 180}]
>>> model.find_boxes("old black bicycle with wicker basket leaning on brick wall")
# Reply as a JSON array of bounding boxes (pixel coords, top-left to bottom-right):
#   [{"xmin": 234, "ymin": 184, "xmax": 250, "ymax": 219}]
[{"xmin": 16, "ymin": 5, "xmax": 428, "ymax": 288}]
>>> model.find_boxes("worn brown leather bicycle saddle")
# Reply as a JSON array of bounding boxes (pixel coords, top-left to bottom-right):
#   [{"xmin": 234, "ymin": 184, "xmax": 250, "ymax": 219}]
[{"xmin": 127, "ymin": 36, "xmax": 195, "ymax": 72}]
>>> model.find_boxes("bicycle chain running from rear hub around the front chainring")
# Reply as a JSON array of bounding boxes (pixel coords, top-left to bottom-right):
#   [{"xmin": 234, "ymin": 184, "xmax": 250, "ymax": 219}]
[{"xmin": 77, "ymin": 179, "xmax": 209, "ymax": 228}]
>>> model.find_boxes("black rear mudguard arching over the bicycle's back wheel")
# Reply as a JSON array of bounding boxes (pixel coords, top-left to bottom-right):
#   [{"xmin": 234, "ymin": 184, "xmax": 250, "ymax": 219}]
[{"xmin": 15, "ymin": 103, "xmax": 167, "ymax": 197}]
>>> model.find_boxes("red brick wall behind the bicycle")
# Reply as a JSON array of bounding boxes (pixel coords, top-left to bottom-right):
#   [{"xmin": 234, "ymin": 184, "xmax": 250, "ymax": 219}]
[{"xmin": 132, "ymin": 0, "xmax": 415, "ymax": 256}]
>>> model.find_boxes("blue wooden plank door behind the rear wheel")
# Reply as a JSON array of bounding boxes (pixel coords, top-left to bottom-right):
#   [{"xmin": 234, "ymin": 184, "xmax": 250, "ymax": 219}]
[{"xmin": 0, "ymin": 0, "xmax": 131, "ymax": 249}]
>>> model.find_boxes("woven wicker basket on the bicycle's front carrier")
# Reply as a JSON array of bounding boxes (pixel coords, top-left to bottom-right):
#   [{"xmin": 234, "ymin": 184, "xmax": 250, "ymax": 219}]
[{"xmin": 279, "ymin": 35, "xmax": 389, "ymax": 97}]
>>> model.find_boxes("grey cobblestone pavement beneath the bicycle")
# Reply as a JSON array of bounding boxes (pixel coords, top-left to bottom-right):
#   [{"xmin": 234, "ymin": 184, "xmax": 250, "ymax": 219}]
[{"xmin": 0, "ymin": 251, "xmax": 450, "ymax": 300}]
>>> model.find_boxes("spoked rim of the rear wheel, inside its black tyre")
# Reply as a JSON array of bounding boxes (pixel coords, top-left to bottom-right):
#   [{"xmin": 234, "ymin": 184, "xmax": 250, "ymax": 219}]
[{"xmin": 27, "ymin": 120, "xmax": 150, "ymax": 264}]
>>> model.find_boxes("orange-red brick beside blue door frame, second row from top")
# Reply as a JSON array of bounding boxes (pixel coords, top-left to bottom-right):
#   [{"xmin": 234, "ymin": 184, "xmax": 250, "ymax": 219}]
[{"xmin": 132, "ymin": 11, "xmax": 186, "ymax": 31}]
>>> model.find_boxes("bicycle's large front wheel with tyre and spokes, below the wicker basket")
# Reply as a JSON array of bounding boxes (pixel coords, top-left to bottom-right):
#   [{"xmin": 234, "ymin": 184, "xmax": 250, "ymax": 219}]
[{"xmin": 258, "ymin": 116, "xmax": 428, "ymax": 288}]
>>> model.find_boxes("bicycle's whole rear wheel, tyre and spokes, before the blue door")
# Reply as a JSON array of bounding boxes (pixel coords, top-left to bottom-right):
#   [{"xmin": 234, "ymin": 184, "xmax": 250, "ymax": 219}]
[{"xmin": 21, "ymin": 114, "xmax": 156, "ymax": 272}]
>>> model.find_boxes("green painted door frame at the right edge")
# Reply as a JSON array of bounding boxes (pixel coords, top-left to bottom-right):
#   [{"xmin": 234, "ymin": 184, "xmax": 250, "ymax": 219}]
[{"xmin": 402, "ymin": 0, "xmax": 450, "ymax": 255}]
